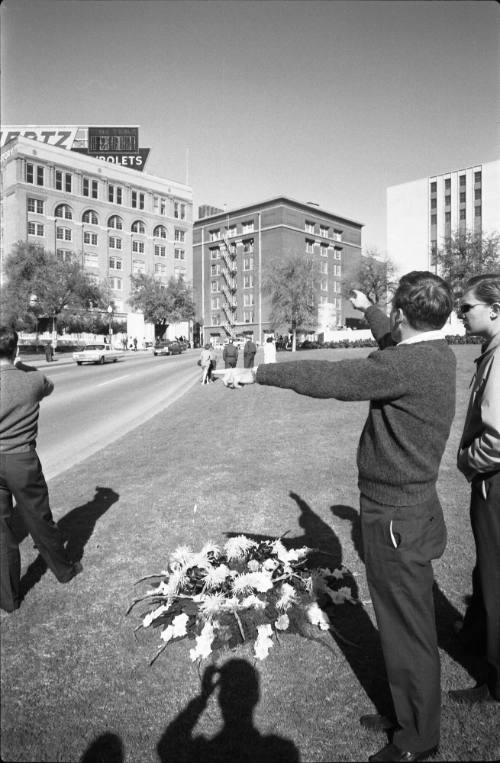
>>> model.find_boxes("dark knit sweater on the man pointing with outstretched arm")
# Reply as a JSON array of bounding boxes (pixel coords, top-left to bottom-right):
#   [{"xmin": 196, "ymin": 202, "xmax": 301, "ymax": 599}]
[{"xmin": 256, "ymin": 307, "xmax": 456, "ymax": 506}]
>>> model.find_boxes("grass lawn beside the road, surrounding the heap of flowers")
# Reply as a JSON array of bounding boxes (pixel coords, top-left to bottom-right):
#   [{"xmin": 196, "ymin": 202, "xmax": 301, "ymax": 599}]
[{"xmin": 1, "ymin": 345, "xmax": 500, "ymax": 763}]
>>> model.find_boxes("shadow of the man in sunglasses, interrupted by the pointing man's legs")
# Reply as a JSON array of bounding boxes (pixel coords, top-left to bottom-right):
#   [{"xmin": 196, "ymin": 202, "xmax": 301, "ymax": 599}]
[{"xmin": 331, "ymin": 505, "xmax": 484, "ymax": 683}]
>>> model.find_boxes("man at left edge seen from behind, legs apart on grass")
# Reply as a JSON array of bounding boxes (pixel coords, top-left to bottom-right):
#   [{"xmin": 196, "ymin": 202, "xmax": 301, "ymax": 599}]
[{"xmin": 0, "ymin": 326, "xmax": 82, "ymax": 612}]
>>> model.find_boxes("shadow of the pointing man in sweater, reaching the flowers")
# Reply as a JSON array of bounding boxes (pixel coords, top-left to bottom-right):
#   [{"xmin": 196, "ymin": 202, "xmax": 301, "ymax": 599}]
[{"xmin": 226, "ymin": 492, "xmax": 394, "ymax": 717}]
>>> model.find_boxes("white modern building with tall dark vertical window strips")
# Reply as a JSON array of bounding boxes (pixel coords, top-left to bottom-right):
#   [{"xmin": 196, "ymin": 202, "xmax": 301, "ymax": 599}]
[{"xmin": 387, "ymin": 161, "xmax": 500, "ymax": 273}]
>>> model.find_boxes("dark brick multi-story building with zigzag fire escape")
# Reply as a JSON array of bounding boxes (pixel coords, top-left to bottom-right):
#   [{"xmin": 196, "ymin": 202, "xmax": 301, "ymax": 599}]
[{"xmin": 193, "ymin": 196, "xmax": 362, "ymax": 342}]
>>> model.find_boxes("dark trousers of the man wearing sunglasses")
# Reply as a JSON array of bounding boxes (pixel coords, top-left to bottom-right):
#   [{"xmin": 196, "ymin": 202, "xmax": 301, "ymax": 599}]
[{"xmin": 461, "ymin": 472, "xmax": 500, "ymax": 700}]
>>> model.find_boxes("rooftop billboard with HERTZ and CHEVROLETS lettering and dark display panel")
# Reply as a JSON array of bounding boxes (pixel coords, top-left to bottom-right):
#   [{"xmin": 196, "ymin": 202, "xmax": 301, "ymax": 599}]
[{"xmin": 0, "ymin": 125, "xmax": 150, "ymax": 172}]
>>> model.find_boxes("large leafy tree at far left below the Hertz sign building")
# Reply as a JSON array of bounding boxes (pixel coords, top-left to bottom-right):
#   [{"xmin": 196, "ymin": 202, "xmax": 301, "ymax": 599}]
[{"xmin": 2, "ymin": 241, "xmax": 109, "ymax": 328}]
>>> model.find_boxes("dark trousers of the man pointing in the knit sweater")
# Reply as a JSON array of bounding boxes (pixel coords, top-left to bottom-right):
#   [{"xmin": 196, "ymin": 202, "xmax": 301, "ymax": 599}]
[{"xmin": 361, "ymin": 493, "xmax": 446, "ymax": 752}]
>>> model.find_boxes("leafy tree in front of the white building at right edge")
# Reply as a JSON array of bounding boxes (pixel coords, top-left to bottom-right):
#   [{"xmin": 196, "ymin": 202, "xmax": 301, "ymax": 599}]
[{"xmin": 433, "ymin": 231, "xmax": 500, "ymax": 299}]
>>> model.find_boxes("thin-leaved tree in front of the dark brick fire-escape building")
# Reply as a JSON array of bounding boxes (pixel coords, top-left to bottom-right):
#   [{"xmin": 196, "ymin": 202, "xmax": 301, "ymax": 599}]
[{"xmin": 262, "ymin": 255, "xmax": 319, "ymax": 351}]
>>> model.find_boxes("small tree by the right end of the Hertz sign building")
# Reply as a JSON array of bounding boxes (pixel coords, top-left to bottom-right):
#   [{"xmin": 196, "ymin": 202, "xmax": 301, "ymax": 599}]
[{"xmin": 129, "ymin": 273, "xmax": 195, "ymax": 337}]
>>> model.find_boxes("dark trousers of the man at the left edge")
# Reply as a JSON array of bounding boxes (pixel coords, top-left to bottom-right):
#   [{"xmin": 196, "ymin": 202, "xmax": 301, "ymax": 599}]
[{"xmin": 0, "ymin": 450, "xmax": 73, "ymax": 612}]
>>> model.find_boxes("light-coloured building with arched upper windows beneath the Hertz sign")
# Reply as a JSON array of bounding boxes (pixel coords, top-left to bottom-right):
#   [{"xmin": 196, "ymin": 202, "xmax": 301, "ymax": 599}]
[{"xmin": 1, "ymin": 136, "xmax": 193, "ymax": 328}]
